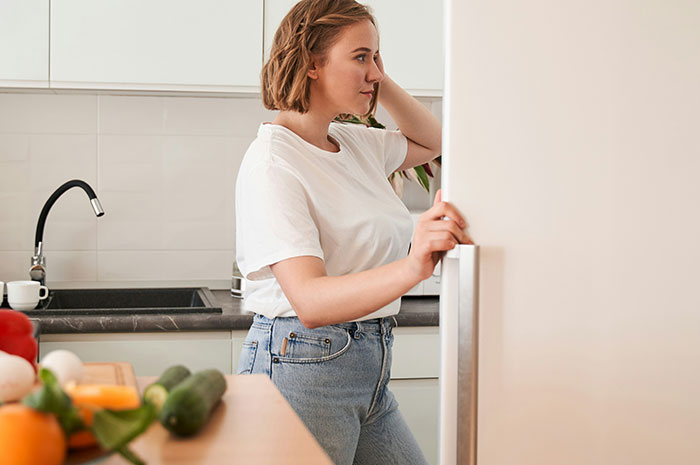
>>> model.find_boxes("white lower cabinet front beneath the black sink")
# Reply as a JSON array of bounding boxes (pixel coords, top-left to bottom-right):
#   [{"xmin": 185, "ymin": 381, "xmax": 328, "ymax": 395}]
[{"xmin": 39, "ymin": 331, "xmax": 231, "ymax": 376}]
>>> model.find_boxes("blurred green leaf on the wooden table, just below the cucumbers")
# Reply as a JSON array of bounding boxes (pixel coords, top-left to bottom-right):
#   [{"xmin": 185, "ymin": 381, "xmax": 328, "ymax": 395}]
[{"xmin": 92, "ymin": 402, "xmax": 156, "ymax": 451}]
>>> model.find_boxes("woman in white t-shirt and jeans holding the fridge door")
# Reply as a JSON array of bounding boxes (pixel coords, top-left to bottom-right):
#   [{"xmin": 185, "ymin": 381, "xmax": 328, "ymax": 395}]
[{"xmin": 236, "ymin": 0, "xmax": 472, "ymax": 465}]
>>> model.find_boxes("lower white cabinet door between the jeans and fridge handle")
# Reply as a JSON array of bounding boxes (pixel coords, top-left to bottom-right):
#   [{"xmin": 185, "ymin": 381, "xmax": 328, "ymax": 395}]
[{"xmin": 389, "ymin": 379, "xmax": 439, "ymax": 465}]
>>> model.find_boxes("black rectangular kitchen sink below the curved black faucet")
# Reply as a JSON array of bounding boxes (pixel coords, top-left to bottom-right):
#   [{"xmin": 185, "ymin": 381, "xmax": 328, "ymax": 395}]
[{"xmin": 24, "ymin": 287, "xmax": 221, "ymax": 316}]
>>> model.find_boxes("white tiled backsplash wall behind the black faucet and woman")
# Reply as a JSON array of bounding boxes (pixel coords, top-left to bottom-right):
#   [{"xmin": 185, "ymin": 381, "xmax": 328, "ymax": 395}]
[{"xmin": 0, "ymin": 93, "xmax": 441, "ymax": 288}]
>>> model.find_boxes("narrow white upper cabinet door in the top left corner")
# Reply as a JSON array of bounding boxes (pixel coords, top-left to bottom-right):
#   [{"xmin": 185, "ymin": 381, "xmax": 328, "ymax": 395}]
[{"xmin": 0, "ymin": 0, "xmax": 49, "ymax": 87}]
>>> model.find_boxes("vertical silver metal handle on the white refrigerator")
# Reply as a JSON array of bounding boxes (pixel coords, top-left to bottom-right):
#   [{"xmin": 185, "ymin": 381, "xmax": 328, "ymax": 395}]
[{"xmin": 440, "ymin": 245, "xmax": 479, "ymax": 465}]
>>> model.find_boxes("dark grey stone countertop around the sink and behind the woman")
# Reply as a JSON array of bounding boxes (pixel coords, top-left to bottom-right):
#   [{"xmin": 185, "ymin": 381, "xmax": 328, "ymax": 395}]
[{"xmin": 27, "ymin": 290, "xmax": 439, "ymax": 334}]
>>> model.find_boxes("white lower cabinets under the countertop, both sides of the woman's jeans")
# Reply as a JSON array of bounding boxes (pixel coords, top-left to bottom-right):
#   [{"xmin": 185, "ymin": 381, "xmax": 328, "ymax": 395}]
[{"xmin": 39, "ymin": 326, "xmax": 440, "ymax": 465}]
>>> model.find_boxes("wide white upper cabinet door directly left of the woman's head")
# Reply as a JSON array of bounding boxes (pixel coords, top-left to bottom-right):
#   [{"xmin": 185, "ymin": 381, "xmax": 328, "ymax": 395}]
[{"xmin": 51, "ymin": 0, "xmax": 262, "ymax": 92}]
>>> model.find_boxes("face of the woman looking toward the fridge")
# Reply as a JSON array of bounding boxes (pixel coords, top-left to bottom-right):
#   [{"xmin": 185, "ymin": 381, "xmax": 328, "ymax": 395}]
[{"xmin": 309, "ymin": 21, "xmax": 384, "ymax": 115}]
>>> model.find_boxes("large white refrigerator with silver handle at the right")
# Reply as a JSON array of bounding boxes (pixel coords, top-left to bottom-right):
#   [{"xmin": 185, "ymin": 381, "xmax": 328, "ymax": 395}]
[{"xmin": 439, "ymin": 0, "xmax": 700, "ymax": 465}]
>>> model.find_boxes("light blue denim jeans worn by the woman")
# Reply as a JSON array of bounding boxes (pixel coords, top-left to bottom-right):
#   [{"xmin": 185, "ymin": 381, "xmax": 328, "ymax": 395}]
[{"xmin": 238, "ymin": 314, "xmax": 427, "ymax": 465}]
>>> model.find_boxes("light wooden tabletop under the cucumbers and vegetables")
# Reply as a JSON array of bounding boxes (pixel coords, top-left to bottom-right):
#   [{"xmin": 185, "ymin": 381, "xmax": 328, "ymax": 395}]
[{"xmin": 100, "ymin": 375, "xmax": 333, "ymax": 465}]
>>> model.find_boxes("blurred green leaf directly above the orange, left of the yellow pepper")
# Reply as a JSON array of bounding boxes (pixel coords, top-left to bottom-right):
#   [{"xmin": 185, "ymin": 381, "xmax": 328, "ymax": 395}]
[{"xmin": 22, "ymin": 368, "xmax": 85, "ymax": 436}]
